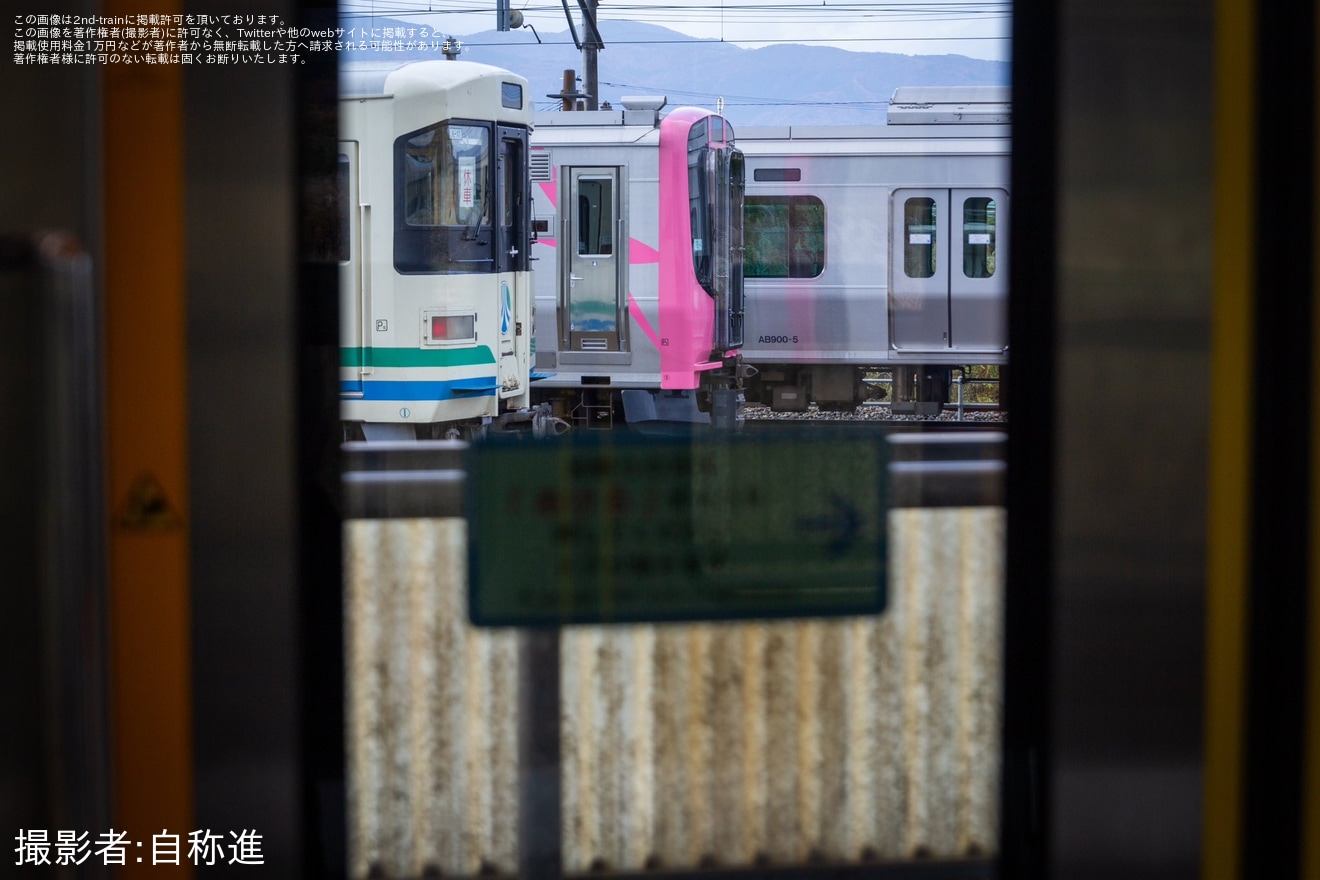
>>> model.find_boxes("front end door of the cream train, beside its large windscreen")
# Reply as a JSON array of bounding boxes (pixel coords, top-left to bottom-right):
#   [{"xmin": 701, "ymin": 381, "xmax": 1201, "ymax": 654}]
[{"xmin": 495, "ymin": 125, "xmax": 532, "ymax": 397}]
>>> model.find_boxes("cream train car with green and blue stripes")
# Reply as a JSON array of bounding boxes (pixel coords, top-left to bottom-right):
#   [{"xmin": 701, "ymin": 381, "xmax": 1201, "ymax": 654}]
[{"xmin": 339, "ymin": 61, "xmax": 532, "ymax": 439}]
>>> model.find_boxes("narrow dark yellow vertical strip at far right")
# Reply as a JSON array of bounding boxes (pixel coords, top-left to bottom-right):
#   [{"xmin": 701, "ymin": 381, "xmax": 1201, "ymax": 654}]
[{"xmin": 1201, "ymin": 0, "xmax": 1255, "ymax": 880}]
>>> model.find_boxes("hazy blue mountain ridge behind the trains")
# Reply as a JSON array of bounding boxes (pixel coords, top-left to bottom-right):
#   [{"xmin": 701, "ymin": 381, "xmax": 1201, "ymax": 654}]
[{"xmin": 341, "ymin": 16, "xmax": 1010, "ymax": 125}]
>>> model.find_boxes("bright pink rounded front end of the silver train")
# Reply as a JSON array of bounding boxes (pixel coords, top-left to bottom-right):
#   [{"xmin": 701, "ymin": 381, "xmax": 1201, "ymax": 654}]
[{"xmin": 659, "ymin": 108, "xmax": 744, "ymax": 420}]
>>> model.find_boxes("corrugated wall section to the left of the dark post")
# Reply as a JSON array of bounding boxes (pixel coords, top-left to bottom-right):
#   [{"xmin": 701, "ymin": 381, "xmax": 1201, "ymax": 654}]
[{"xmin": 345, "ymin": 520, "xmax": 517, "ymax": 877}]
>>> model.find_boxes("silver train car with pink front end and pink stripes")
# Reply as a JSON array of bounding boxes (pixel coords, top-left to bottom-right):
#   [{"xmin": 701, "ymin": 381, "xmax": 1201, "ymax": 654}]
[{"xmin": 532, "ymin": 99, "xmax": 743, "ymax": 422}]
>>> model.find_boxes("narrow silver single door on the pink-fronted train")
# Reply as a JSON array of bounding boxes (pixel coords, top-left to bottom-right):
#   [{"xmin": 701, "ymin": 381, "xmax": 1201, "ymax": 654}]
[{"xmin": 560, "ymin": 168, "xmax": 626, "ymax": 351}]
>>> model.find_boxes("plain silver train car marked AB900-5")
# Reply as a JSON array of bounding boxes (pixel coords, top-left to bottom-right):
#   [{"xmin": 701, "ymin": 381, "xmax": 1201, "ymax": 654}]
[{"xmin": 739, "ymin": 87, "xmax": 1010, "ymax": 410}]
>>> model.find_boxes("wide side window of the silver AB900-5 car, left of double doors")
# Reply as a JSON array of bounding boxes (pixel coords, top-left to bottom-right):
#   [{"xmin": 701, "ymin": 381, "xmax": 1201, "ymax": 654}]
[{"xmin": 743, "ymin": 195, "xmax": 825, "ymax": 278}]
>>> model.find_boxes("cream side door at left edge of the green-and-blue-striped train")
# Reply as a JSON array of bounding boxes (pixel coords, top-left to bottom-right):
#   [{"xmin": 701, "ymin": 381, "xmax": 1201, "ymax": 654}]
[{"xmin": 338, "ymin": 141, "xmax": 371, "ymax": 397}]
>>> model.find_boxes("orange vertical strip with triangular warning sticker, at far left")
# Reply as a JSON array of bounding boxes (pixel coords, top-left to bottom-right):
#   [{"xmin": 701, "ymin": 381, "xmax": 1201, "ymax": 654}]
[{"xmin": 103, "ymin": 0, "xmax": 194, "ymax": 879}]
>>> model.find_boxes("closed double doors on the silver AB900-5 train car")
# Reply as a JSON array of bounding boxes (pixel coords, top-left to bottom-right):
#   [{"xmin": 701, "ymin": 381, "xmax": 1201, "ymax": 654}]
[{"xmin": 890, "ymin": 189, "xmax": 1008, "ymax": 351}]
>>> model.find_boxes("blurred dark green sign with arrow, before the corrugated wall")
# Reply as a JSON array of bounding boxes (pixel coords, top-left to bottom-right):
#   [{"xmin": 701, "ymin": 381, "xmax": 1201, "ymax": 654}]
[{"xmin": 465, "ymin": 431, "xmax": 888, "ymax": 627}]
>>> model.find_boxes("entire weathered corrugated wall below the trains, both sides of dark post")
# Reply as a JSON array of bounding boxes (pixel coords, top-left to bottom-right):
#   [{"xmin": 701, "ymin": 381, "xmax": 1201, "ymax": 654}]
[{"xmin": 346, "ymin": 508, "xmax": 1003, "ymax": 877}]
